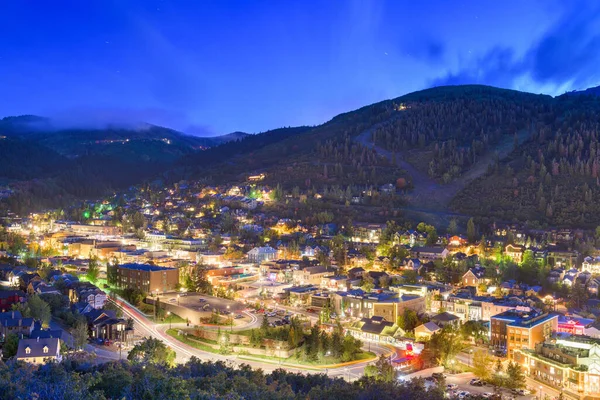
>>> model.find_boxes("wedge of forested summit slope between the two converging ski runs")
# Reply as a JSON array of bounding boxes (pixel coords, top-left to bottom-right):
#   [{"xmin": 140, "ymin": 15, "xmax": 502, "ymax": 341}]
[{"xmin": 373, "ymin": 86, "xmax": 553, "ymax": 183}]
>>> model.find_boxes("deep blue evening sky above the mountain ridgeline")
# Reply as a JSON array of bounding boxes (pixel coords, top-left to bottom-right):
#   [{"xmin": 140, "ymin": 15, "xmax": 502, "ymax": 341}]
[{"xmin": 0, "ymin": 0, "xmax": 600, "ymax": 134}]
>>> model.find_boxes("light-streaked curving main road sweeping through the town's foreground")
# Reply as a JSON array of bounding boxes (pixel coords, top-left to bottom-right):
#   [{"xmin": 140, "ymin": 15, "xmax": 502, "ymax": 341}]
[{"xmin": 117, "ymin": 300, "xmax": 391, "ymax": 380}]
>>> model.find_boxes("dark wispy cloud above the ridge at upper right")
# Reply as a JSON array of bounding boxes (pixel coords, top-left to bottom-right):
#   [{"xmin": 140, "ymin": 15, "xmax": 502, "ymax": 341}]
[{"xmin": 431, "ymin": 4, "xmax": 600, "ymax": 94}]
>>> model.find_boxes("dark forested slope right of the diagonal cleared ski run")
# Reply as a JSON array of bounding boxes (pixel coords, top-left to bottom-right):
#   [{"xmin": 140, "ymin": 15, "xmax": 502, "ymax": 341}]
[{"xmin": 453, "ymin": 92, "xmax": 600, "ymax": 227}]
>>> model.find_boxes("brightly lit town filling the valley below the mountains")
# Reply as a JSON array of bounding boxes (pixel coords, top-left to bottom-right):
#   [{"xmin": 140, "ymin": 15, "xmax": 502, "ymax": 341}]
[{"xmin": 0, "ymin": 173, "xmax": 600, "ymax": 399}]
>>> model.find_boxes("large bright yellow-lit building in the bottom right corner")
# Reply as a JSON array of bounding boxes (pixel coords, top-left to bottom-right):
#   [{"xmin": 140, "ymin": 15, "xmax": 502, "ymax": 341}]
[{"xmin": 514, "ymin": 337, "xmax": 600, "ymax": 400}]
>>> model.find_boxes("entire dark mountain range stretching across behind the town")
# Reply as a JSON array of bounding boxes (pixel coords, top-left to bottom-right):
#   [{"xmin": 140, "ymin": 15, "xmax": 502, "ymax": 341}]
[{"xmin": 5, "ymin": 85, "xmax": 600, "ymax": 227}]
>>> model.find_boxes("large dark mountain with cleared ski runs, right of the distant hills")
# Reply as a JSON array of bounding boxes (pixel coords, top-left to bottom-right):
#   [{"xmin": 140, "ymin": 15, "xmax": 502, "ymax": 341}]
[{"xmin": 198, "ymin": 85, "xmax": 600, "ymax": 227}]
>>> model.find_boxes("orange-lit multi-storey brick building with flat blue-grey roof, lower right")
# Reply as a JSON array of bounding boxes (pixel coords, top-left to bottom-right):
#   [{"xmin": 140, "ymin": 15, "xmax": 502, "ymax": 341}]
[{"xmin": 490, "ymin": 310, "xmax": 558, "ymax": 359}]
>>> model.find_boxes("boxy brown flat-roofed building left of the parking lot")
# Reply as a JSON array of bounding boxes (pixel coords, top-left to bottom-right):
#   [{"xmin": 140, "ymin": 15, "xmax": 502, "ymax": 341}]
[{"xmin": 117, "ymin": 264, "xmax": 179, "ymax": 293}]
